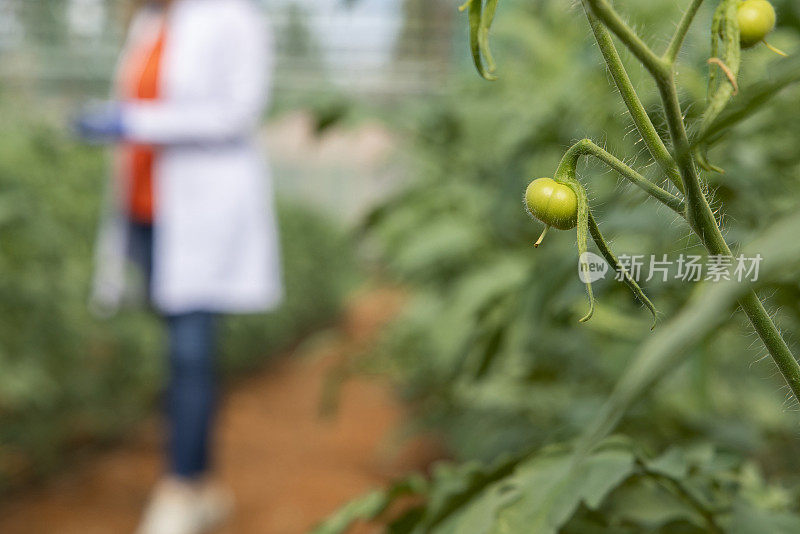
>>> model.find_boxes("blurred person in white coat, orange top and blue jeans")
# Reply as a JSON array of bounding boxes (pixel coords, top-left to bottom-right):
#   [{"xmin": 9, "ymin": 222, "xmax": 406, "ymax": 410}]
[{"xmin": 75, "ymin": 0, "xmax": 282, "ymax": 534}]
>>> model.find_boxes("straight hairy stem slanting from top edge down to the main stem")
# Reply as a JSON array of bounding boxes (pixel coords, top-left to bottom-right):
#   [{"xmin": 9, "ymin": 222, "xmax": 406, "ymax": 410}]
[{"xmin": 582, "ymin": 0, "xmax": 683, "ymax": 193}]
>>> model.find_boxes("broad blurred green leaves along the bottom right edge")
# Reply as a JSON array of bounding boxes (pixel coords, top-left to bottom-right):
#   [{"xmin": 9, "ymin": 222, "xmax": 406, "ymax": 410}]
[{"xmin": 314, "ymin": 438, "xmax": 800, "ymax": 534}]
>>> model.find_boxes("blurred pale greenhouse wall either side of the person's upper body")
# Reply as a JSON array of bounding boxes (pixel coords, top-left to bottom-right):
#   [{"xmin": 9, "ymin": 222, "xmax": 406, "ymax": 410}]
[{"xmin": 0, "ymin": 0, "xmax": 457, "ymax": 99}]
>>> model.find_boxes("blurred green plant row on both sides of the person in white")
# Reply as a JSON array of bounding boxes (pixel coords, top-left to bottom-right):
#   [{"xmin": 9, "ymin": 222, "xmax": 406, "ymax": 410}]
[{"xmin": 0, "ymin": 102, "xmax": 355, "ymax": 492}]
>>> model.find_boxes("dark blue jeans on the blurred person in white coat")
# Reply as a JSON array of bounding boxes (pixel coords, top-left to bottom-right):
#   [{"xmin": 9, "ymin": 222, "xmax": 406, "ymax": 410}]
[{"xmin": 128, "ymin": 222, "xmax": 216, "ymax": 478}]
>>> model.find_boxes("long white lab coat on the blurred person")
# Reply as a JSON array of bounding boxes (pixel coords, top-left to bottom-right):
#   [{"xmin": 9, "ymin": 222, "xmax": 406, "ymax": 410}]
[{"xmin": 93, "ymin": 0, "xmax": 282, "ymax": 314}]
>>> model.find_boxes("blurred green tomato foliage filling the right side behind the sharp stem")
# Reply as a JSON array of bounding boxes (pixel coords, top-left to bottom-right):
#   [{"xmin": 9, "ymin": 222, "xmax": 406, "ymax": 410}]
[{"xmin": 319, "ymin": 0, "xmax": 800, "ymax": 534}]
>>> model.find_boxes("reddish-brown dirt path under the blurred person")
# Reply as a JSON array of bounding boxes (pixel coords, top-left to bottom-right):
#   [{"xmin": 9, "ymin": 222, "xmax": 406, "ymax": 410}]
[{"xmin": 0, "ymin": 290, "xmax": 439, "ymax": 534}]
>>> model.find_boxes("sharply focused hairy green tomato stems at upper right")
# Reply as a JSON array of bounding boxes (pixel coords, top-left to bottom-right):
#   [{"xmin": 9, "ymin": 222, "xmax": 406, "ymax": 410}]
[{"xmin": 472, "ymin": 0, "xmax": 800, "ymax": 482}]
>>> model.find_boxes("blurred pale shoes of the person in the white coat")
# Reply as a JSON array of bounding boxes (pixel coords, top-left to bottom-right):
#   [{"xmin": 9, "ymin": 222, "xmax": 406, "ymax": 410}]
[{"xmin": 136, "ymin": 478, "xmax": 233, "ymax": 534}]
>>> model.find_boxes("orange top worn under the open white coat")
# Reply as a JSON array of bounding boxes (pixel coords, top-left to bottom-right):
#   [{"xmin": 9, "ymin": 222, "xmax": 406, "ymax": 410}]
[{"xmin": 121, "ymin": 24, "xmax": 166, "ymax": 223}]
